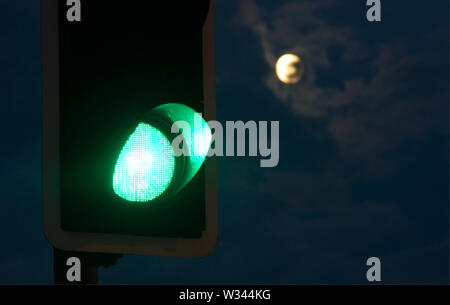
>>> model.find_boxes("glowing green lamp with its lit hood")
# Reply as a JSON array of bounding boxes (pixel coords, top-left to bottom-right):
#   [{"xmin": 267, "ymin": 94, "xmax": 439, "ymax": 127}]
[{"xmin": 113, "ymin": 103, "xmax": 212, "ymax": 202}]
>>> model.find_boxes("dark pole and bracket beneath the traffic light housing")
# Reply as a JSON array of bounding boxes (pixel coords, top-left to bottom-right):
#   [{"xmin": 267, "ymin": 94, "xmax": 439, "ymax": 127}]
[{"xmin": 53, "ymin": 248, "xmax": 123, "ymax": 285}]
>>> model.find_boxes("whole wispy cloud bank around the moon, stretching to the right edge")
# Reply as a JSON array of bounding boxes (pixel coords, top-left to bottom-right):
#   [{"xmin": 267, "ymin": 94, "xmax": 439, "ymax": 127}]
[{"xmin": 237, "ymin": 0, "xmax": 448, "ymax": 162}]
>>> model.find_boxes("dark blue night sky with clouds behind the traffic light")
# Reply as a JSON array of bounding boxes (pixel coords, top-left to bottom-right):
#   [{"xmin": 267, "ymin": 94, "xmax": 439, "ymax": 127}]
[{"xmin": 0, "ymin": 0, "xmax": 449, "ymax": 284}]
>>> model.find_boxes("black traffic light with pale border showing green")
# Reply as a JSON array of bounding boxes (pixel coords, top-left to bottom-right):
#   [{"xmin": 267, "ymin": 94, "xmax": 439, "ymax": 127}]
[{"xmin": 41, "ymin": 0, "xmax": 217, "ymax": 257}]
